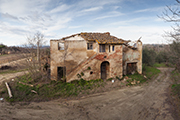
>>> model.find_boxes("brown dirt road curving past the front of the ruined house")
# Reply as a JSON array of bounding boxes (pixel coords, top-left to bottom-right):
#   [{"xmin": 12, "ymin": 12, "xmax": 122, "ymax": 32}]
[{"xmin": 0, "ymin": 68, "xmax": 175, "ymax": 120}]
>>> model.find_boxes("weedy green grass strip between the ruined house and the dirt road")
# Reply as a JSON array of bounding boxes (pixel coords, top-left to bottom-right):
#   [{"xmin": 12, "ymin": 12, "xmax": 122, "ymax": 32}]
[{"xmin": 0, "ymin": 66, "xmax": 160, "ymax": 102}]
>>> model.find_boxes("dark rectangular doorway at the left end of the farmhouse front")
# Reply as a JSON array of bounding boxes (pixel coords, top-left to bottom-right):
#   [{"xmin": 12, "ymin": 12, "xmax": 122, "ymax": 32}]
[{"xmin": 57, "ymin": 67, "xmax": 66, "ymax": 81}]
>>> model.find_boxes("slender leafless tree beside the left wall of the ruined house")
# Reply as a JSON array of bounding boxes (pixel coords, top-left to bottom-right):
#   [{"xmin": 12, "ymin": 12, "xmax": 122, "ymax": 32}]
[{"xmin": 22, "ymin": 32, "xmax": 49, "ymax": 81}]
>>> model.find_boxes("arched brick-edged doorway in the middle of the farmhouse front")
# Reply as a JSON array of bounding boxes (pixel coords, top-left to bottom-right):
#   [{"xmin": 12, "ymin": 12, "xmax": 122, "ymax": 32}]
[{"xmin": 101, "ymin": 61, "xmax": 109, "ymax": 80}]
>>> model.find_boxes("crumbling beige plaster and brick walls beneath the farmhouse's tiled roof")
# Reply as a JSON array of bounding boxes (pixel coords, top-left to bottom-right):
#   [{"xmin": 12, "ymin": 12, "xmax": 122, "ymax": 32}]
[{"xmin": 50, "ymin": 34, "xmax": 142, "ymax": 82}]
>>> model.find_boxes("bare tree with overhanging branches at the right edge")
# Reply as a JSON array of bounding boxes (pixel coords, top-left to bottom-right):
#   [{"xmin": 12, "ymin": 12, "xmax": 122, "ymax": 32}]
[{"xmin": 159, "ymin": 0, "xmax": 180, "ymax": 71}]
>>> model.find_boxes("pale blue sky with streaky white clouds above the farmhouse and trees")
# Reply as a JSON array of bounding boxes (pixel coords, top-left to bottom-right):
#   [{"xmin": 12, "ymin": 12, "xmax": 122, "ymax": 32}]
[{"xmin": 0, "ymin": 0, "xmax": 175, "ymax": 46}]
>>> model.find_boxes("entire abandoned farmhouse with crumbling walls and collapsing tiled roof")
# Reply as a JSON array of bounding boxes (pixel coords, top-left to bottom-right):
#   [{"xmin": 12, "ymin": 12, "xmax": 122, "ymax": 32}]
[{"xmin": 50, "ymin": 32, "xmax": 142, "ymax": 82}]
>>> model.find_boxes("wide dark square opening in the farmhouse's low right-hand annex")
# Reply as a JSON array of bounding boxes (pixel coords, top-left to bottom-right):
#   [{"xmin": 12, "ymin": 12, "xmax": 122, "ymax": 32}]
[{"xmin": 126, "ymin": 63, "xmax": 137, "ymax": 75}]
